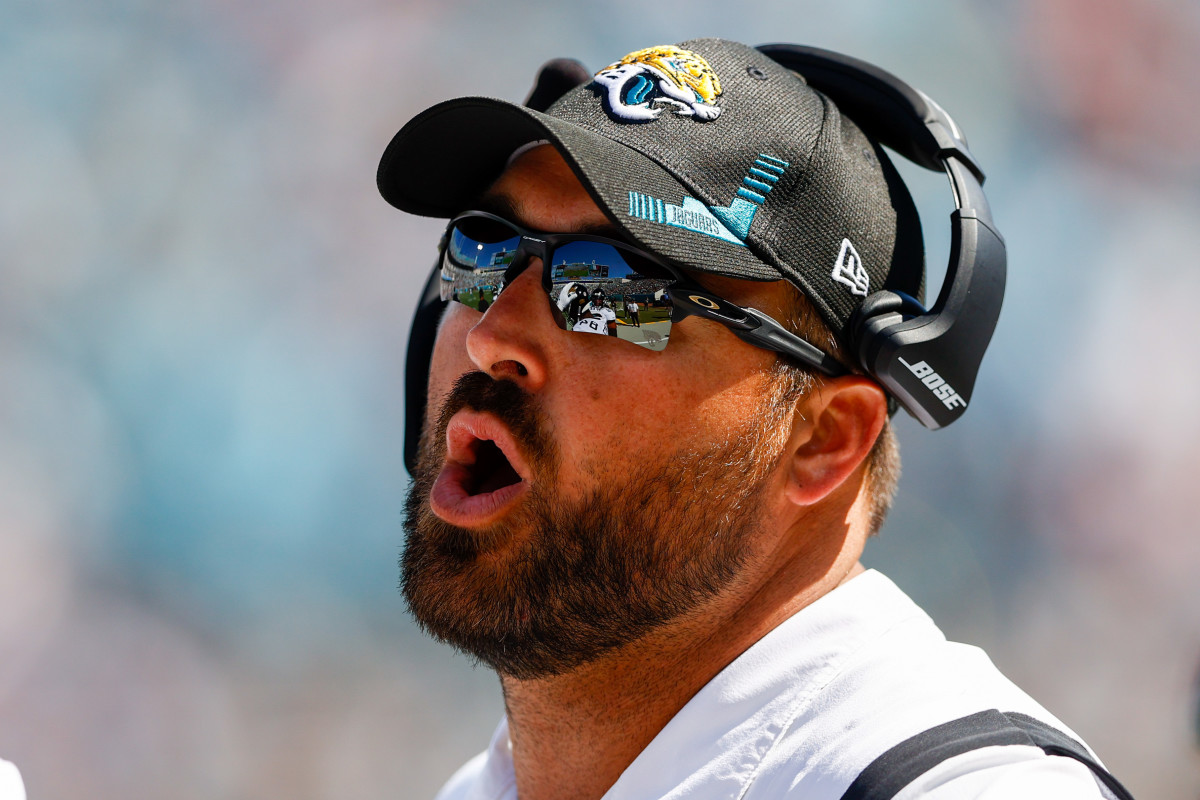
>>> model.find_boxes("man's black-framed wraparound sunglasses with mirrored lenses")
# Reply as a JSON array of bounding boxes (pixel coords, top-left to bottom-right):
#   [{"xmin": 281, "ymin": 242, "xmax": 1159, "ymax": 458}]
[{"xmin": 440, "ymin": 211, "xmax": 848, "ymax": 375}]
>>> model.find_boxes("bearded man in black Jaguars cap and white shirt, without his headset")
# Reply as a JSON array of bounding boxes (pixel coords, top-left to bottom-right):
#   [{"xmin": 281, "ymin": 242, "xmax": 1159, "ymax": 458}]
[{"xmin": 379, "ymin": 40, "xmax": 1123, "ymax": 800}]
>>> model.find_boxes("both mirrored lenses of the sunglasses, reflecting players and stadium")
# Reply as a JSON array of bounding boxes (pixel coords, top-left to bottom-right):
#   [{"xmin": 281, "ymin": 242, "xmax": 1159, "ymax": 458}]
[{"xmin": 442, "ymin": 217, "xmax": 674, "ymax": 350}]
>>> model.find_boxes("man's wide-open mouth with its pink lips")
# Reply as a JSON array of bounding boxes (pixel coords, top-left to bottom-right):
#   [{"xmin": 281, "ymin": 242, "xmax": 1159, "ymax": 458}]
[{"xmin": 430, "ymin": 409, "xmax": 529, "ymax": 527}]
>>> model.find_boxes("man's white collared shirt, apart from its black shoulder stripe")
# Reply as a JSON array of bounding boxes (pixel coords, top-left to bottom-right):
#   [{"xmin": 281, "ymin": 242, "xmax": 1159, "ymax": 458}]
[{"xmin": 438, "ymin": 570, "xmax": 1102, "ymax": 800}]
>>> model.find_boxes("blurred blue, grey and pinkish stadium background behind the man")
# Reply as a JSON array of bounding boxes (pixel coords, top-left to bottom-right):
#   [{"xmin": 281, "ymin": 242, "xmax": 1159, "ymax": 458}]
[{"xmin": 0, "ymin": 0, "xmax": 1200, "ymax": 800}]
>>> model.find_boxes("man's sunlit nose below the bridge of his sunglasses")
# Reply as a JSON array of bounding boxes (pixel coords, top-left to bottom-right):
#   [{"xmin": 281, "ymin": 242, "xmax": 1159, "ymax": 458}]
[{"xmin": 467, "ymin": 258, "xmax": 560, "ymax": 391}]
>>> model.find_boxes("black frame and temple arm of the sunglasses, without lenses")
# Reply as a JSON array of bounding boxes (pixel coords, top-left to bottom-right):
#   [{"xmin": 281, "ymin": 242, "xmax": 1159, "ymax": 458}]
[{"xmin": 438, "ymin": 211, "xmax": 850, "ymax": 378}]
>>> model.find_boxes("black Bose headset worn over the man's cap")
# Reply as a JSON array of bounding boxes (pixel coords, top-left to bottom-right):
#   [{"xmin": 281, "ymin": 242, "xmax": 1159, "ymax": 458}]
[{"xmin": 404, "ymin": 44, "xmax": 1006, "ymax": 473}]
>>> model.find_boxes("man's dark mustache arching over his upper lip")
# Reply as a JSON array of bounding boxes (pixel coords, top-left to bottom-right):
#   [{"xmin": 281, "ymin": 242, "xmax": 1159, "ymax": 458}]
[{"xmin": 433, "ymin": 372, "xmax": 553, "ymax": 468}]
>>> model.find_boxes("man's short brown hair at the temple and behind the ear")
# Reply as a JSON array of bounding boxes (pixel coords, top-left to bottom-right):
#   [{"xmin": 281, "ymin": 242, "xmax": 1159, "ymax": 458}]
[{"xmin": 773, "ymin": 283, "xmax": 900, "ymax": 536}]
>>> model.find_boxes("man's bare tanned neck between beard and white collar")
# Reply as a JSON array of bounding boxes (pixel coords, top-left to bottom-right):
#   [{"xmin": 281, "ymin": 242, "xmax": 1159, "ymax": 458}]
[{"xmin": 502, "ymin": 532, "xmax": 863, "ymax": 800}]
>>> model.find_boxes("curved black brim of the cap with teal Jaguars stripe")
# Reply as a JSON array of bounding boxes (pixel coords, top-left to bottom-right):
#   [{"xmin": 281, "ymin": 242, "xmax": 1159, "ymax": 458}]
[{"xmin": 377, "ymin": 97, "xmax": 782, "ymax": 281}]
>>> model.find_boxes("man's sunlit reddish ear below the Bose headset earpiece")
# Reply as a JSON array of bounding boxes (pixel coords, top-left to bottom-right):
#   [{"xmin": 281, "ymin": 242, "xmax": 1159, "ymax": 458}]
[{"xmin": 786, "ymin": 375, "xmax": 888, "ymax": 506}]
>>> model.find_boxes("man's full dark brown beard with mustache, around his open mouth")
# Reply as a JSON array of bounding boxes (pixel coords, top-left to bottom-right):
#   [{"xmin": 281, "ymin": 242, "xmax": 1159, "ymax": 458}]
[{"xmin": 401, "ymin": 372, "xmax": 782, "ymax": 679}]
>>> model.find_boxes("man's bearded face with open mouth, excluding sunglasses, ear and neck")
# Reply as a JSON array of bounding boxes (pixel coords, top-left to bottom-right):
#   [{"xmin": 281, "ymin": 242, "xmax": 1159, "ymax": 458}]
[{"xmin": 402, "ymin": 146, "xmax": 790, "ymax": 678}]
